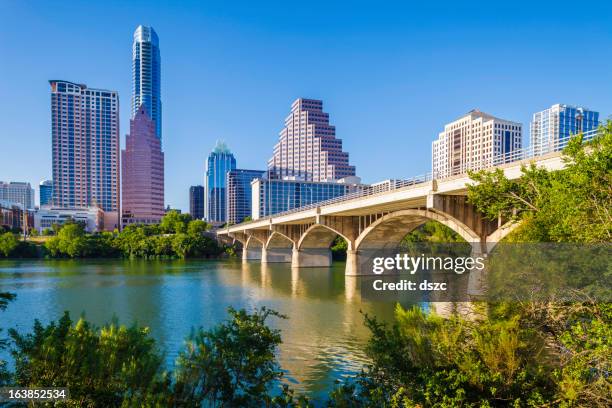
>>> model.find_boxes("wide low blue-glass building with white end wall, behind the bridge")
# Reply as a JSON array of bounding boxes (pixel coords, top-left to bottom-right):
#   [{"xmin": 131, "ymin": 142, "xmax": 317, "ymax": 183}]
[{"xmin": 251, "ymin": 177, "xmax": 367, "ymax": 220}]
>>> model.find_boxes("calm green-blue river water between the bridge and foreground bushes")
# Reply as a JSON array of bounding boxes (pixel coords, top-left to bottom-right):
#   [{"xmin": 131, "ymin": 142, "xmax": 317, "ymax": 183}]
[{"xmin": 0, "ymin": 260, "xmax": 394, "ymax": 397}]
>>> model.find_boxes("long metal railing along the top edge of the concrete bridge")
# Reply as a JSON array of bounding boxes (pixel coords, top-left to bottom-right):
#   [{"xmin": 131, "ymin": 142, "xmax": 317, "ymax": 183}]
[{"xmin": 233, "ymin": 129, "xmax": 599, "ymax": 224}]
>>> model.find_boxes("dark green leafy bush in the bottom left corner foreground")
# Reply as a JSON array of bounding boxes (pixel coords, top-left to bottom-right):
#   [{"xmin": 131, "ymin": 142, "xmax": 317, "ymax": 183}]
[{"xmin": 9, "ymin": 312, "xmax": 169, "ymax": 407}]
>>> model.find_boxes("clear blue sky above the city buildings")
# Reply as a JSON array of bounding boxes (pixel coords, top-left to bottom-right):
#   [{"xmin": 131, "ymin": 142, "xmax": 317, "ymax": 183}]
[{"xmin": 0, "ymin": 0, "xmax": 612, "ymax": 210}]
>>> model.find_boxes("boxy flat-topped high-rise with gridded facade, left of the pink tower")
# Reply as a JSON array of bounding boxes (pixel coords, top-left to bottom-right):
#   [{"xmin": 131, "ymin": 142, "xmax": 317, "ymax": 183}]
[{"xmin": 49, "ymin": 80, "xmax": 119, "ymax": 228}]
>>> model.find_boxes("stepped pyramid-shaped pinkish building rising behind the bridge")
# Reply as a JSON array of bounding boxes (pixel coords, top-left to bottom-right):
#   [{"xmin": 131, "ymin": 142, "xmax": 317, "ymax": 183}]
[{"xmin": 268, "ymin": 98, "xmax": 355, "ymax": 181}]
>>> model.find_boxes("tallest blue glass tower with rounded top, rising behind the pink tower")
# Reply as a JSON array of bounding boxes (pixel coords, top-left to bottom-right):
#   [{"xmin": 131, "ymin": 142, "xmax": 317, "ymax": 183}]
[{"xmin": 132, "ymin": 25, "xmax": 162, "ymax": 139}]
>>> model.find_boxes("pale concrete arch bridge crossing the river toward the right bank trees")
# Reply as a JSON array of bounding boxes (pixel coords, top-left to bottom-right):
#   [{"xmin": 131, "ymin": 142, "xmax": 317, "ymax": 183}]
[{"xmin": 217, "ymin": 132, "xmax": 596, "ymax": 275}]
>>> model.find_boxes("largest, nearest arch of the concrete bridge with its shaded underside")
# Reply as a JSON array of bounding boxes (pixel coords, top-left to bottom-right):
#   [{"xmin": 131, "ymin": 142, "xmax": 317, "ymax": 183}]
[{"xmin": 355, "ymin": 209, "xmax": 481, "ymax": 250}]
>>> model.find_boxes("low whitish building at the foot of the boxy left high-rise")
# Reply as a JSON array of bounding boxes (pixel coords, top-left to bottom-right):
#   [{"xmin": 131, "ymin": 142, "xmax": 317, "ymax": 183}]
[{"xmin": 34, "ymin": 207, "xmax": 105, "ymax": 233}]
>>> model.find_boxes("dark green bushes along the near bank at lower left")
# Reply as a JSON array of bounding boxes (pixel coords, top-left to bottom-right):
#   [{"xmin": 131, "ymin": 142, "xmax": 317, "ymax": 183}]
[{"xmin": 10, "ymin": 308, "xmax": 308, "ymax": 407}]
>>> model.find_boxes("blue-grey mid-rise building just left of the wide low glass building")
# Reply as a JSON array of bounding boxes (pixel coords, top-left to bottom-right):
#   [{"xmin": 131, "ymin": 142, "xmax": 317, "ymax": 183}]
[{"xmin": 225, "ymin": 169, "xmax": 266, "ymax": 224}]
